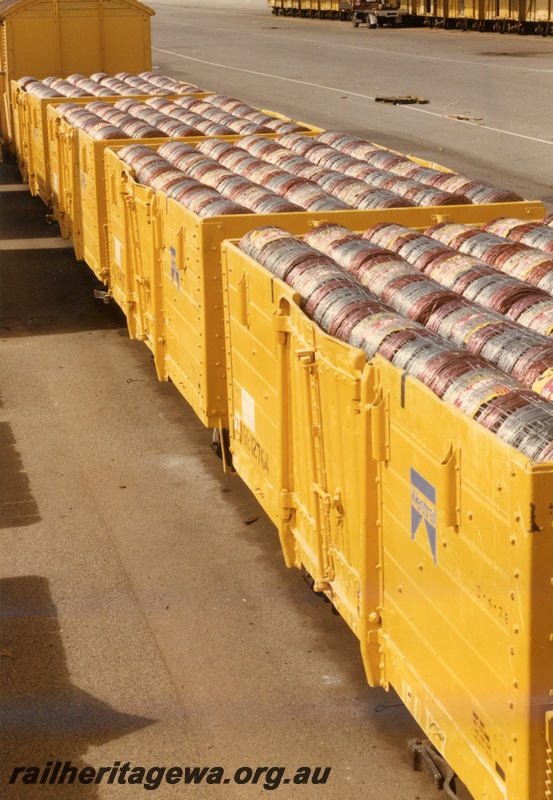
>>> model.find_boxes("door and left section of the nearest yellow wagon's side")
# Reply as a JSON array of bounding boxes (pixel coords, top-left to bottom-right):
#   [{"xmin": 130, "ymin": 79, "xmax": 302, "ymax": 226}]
[{"xmin": 223, "ymin": 243, "xmax": 380, "ymax": 685}]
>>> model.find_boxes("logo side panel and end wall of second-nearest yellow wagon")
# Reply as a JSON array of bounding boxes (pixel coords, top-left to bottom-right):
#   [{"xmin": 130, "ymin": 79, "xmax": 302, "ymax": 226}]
[{"xmin": 159, "ymin": 200, "xmax": 528, "ymax": 427}]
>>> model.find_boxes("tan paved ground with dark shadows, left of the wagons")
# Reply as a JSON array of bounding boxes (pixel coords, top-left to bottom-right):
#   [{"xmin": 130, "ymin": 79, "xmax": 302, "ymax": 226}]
[{"xmin": 0, "ymin": 159, "xmax": 458, "ymax": 800}]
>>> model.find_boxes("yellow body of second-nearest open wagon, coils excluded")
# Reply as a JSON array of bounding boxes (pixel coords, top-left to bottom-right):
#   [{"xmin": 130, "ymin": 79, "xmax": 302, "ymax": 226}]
[{"xmin": 101, "ymin": 142, "xmax": 545, "ymax": 428}]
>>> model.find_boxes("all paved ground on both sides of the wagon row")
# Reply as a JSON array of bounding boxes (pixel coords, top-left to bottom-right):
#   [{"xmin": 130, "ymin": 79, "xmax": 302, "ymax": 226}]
[{"xmin": 0, "ymin": 0, "xmax": 553, "ymax": 800}]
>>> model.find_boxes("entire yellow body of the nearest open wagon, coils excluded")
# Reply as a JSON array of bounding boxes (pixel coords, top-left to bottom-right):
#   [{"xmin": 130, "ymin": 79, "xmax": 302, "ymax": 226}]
[{"xmin": 223, "ymin": 238, "xmax": 553, "ymax": 800}]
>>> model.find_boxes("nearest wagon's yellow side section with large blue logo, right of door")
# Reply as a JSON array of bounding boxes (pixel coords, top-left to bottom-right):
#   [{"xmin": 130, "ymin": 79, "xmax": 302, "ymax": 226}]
[{"xmin": 379, "ymin": 354, "xmax": 553, "ymax": 800}]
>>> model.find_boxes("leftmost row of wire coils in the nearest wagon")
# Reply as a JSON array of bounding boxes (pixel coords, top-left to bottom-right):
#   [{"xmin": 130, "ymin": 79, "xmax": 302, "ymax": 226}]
[{"xmin": 240, "ymin": 226, "xmax": 553, "ymax": 461}]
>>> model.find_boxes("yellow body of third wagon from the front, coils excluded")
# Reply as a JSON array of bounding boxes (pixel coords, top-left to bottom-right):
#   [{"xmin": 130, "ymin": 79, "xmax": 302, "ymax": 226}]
[{"xmin": 46, "ymin": 106, "xmax": 320, "ymax": 283}]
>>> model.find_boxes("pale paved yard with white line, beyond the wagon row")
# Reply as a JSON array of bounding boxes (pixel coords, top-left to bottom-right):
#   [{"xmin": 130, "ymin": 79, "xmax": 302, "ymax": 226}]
[{"xmin": 150, "ymin": 0, "xmax": 553, "ymax": 210}]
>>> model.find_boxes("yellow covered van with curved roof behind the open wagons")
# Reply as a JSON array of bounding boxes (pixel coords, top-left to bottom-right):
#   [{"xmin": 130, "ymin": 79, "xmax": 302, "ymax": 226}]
[{"xmin": 0, "ymin": 0, "xmax": 154, "ymax": 148}]
